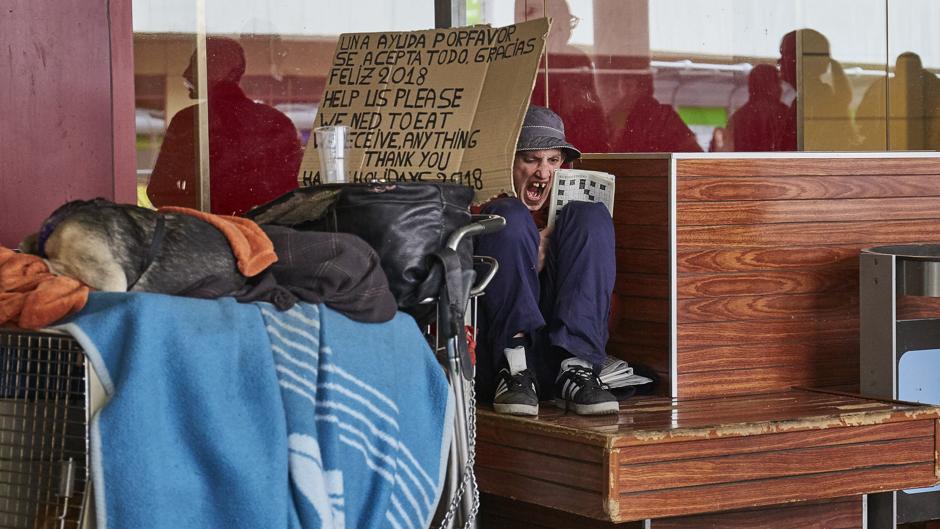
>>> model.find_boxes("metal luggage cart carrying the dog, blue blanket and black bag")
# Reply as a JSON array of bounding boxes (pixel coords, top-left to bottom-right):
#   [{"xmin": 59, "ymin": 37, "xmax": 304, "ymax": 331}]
[{"xmin": 0, "ymin": 215, "xmax": 505, "ymax": 529}]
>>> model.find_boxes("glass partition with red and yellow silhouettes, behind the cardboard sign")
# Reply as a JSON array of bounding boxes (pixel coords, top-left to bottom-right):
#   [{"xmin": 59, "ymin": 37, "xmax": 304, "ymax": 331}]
[{"xmin": 133, "ymin": 0, "xmax": 940, "ymax": 213}]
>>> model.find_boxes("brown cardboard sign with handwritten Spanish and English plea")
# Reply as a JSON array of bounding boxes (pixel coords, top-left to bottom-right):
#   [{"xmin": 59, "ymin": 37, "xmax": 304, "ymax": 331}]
[{"xmin": 298, "ymin": 18, "xmax": 549, "ymax": 201}]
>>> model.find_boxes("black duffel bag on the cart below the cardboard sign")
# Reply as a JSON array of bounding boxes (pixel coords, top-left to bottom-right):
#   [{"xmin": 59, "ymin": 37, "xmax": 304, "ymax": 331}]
[{"xmin": 246, "ymin": 182, "xmax": 474, "ymax": 337}]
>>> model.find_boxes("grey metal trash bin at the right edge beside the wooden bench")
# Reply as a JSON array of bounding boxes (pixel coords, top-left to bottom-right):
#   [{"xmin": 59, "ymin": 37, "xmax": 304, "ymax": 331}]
[{"xmin": 859, "ymin": 244, "xmax": 940, "ymax": 529}]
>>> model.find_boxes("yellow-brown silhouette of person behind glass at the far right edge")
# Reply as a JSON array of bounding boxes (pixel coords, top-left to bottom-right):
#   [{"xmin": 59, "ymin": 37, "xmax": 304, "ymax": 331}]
[{"xmin": 855, "ymin": 52, "xmax": 940, "ymax": 150}]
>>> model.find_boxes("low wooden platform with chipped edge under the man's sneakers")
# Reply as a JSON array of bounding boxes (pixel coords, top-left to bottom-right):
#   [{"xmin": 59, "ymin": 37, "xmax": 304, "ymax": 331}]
[{"xmin": 476, "ymin": 389, "xmax": 940, "ymax": 522}]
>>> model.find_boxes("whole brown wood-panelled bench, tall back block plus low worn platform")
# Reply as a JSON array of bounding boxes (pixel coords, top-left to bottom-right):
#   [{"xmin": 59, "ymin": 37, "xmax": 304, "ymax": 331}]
[{"xmin": 477, "ymin": 153, "xmax": 940, "ymax": 527}]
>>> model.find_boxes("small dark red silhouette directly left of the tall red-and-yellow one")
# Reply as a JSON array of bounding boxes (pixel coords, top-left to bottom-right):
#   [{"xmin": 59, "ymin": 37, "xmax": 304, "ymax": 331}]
[{"xmin": 728, "ymin": 64, "xmax": 790, "ymax": 151}]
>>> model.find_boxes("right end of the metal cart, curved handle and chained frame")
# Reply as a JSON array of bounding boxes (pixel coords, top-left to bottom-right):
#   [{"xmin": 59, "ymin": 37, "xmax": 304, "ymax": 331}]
[{"xmin": 427, "ymin": 215, "xmax": 506, "ymax": 529}]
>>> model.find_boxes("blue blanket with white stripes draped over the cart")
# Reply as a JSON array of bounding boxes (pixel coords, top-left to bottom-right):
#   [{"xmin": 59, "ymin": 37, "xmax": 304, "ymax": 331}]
[{"xmin": 61, "ymin": 293, "xmax": 453, "ymax": 529}]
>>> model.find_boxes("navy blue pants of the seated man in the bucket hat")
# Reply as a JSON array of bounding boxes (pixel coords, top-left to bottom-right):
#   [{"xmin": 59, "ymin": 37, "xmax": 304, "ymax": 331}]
[{"xmin": 475, "ymin": 198, "xmax": 617, "ymax": 401}]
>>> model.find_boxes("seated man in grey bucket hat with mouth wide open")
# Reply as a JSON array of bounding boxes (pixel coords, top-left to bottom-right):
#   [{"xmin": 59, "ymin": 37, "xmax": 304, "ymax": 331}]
[{"xmin": 475, "ymin": 106, "xmax": 619, "ymax": 415}]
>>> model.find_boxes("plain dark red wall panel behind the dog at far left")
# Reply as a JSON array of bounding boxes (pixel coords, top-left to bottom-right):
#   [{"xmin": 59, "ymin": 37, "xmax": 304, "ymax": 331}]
[{"xmin": 0, "ymin": 0, "xmax": 135, "ymax": 247}]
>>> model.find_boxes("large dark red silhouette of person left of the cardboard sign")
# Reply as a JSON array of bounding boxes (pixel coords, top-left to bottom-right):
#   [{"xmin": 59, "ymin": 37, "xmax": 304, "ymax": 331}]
[{"xmin": 147, "ymin": 37, "xmax": 303, "ymax": 215}]
